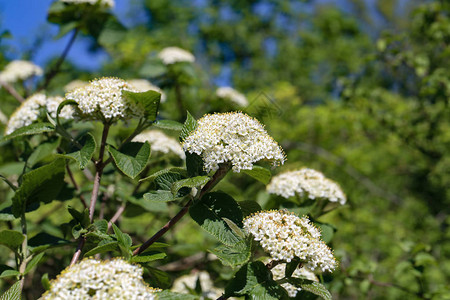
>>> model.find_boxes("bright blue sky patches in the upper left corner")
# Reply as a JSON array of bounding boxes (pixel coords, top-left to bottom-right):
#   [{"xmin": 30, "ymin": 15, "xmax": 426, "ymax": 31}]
[{"xmin": 0, "ymin": 0, "xmax": 129, "ymax": 70}]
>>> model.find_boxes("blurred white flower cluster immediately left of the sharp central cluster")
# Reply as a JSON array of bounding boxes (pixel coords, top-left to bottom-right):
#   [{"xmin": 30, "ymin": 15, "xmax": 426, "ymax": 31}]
[{"xmin": 133, "ymin": 130, "xmax": 186, "ymax": 159}]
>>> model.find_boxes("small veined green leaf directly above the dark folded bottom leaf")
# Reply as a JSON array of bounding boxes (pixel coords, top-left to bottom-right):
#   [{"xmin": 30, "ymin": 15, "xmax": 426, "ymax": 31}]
[{"xmin": 211, "ymin": 240, "xmax": 252, "ymax": 268}]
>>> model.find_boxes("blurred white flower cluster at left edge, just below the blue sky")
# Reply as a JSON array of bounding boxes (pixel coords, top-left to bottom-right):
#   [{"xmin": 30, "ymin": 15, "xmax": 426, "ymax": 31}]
[{"xmin": 0, "ymin": 60, "xmax": 43, "ymax": 83}]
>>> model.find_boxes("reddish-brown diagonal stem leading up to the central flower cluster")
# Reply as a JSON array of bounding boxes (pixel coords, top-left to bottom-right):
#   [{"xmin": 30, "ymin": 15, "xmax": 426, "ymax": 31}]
[{"xmin": 133, "ymin": 164, "xmax": 230, "ymax": 255}]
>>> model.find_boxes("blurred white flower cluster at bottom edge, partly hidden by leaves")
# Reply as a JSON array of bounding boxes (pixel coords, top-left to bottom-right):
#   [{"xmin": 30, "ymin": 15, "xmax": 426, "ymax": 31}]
[{"xmin": 171, "ymin": 271, "xmax": 223, "ymax": 299}]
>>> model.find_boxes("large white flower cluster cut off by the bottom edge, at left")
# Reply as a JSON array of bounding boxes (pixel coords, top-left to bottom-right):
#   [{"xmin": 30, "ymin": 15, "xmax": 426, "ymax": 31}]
[{"xmin": 41, "ymin": 258, "xmax": 160, "ymax": 300}]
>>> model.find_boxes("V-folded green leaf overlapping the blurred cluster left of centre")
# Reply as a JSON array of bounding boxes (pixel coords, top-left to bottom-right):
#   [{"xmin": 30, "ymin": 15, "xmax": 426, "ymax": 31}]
[{"xmin": 108, "ymin": 142, "xmax": 150, "ymax": 179}]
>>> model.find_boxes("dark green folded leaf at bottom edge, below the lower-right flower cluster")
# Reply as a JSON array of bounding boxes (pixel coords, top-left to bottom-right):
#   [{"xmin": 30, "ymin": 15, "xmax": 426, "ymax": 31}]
[{"xmin": 225, "ymin": 261, "xmax": 289, "ymax": 300}]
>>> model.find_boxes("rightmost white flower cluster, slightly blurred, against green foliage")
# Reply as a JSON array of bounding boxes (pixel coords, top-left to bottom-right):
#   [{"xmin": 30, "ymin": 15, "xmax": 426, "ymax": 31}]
[{"xmin": 267, "ymin": 168, "xmax": 346, "ymax": 205}]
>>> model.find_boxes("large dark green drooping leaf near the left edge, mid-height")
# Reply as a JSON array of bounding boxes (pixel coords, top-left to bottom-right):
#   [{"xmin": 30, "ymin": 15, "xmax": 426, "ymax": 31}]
[{"xmin": 12, "ymin": 158, "xmax": 66, "ymax": 218}]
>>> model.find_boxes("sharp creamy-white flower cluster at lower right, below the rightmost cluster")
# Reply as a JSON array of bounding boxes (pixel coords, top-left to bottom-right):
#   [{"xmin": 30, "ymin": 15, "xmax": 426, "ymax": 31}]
[{"xmin": 244, "ymin": 210, "xmax": 336, "ymax": 272}]
